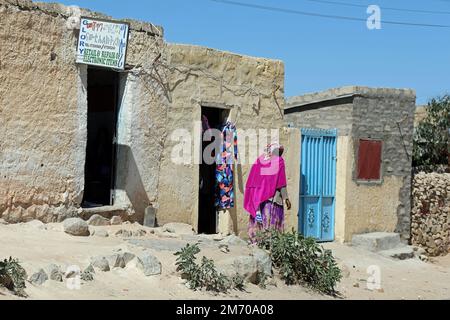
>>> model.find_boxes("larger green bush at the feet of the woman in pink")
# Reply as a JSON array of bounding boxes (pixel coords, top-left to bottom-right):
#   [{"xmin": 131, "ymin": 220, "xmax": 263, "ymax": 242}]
[{"xmin": 257, "ymin": 230, "xmax": 342, "ymax": 295}]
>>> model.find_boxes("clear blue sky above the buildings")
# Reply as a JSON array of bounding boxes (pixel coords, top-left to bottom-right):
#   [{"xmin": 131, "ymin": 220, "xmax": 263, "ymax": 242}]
[{"xmin": 39, "ymin": 0, "xmax": 450, "ymax": 105}]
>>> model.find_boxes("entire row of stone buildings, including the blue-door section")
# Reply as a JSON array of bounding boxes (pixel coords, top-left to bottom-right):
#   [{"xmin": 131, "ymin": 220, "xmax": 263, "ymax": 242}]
[{"xmin": 0, "ymin": 0, "xmax": 415, "ymax": 241}]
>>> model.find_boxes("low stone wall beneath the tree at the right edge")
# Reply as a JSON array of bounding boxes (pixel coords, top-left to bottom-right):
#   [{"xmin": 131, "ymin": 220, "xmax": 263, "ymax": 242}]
[{"xmin": 411, "ymin": 172, "xmax": 450, "ymax": 256}]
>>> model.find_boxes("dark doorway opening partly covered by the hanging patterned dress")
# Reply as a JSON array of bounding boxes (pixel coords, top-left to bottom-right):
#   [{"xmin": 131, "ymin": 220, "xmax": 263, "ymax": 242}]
[{"xmin": 198, "ymin": 107, "xmax": 230, "ymax": 234}]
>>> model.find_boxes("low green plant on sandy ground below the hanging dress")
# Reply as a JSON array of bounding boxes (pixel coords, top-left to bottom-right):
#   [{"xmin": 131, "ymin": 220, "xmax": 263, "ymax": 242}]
[{"xmin": 175, "ymin": 244, "xmax": 244, "ymax": 293}]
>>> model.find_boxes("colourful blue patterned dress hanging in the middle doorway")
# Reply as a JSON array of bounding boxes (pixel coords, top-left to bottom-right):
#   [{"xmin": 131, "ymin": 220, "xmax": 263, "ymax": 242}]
[{"xmin": 215, "ymin": 122, "xmax": 238, "ymax": 209}]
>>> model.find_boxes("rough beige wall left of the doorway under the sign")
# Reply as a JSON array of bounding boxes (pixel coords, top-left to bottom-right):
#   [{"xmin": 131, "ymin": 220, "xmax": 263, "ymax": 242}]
[{"xmin": 0, "ymin": 1, "xmax": 86, "ymax": 222}]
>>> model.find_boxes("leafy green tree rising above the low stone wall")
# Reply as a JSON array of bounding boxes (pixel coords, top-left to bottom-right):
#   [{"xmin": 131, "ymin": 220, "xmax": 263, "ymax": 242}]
[{"xmin": 413, "ymin": 95, "xmax": 450, "ymax": 168}]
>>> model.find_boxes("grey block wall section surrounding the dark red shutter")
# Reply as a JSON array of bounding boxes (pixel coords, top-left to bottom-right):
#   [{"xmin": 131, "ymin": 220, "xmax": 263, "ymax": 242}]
[{"xmin": 349, "ymin": 89, "xmax": 416, "ymax": 241}]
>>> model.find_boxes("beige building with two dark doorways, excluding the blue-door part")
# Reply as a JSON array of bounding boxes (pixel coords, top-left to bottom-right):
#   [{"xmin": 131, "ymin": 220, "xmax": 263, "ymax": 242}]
[{"xmin": 0, "ymin": 0, "xmax": 299, "ymax": 234}]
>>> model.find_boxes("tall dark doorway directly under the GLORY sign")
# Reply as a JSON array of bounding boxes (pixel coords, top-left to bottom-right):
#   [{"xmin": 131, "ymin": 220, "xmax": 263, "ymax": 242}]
[{"xmin": 82, "ymin": 68, "xmax": 119, "ymax": 207}]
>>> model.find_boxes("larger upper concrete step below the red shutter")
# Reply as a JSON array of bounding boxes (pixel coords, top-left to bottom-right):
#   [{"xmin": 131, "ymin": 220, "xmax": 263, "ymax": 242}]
[{"xmin": 352, "ymin": 232, "xmax": 402, "ymax": 252}]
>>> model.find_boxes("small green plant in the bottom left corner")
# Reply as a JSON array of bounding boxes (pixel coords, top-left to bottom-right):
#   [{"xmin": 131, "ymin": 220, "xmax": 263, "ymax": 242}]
[{"xmin": 0, "ymin": 257, "xmax": 27, "ymax": 297}]
